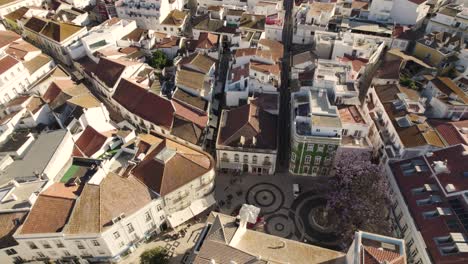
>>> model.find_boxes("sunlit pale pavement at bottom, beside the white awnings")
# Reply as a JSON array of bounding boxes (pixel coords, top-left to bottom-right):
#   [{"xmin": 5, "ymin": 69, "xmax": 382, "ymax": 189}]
[{"xmin": 120, "ymin": 217, "xmax": 206, "ymax": 264}]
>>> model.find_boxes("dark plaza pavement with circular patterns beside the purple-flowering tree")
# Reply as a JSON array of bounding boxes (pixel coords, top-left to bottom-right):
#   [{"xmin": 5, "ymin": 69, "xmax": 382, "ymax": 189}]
[{"xmin": 215, "ymin": 173, "xmax": 340, "ymax": 249}]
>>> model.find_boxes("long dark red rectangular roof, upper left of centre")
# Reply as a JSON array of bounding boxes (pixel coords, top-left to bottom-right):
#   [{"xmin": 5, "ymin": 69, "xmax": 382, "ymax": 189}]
[{"xmin": 112, "ymin": 79, "xmax": 175, "ymax": 128}]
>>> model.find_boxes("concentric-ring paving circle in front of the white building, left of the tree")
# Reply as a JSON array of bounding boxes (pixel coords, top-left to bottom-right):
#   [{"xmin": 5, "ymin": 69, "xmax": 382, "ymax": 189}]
[{"xmin": 245, "ymin": 183, "xmax": 284, "ymax": 215}]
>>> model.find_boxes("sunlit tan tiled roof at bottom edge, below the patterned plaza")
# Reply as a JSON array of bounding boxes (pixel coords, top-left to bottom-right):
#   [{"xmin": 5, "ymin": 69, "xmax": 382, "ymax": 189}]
[{"xmin": 194, "ymin": 213, "xmax": 346, "ymax": 264}]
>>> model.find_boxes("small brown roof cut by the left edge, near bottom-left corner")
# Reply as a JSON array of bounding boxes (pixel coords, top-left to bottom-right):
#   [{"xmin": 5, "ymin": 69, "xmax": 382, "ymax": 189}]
[{"xmin": 0, "ymin": 212, "xmax": 28, "ymax": 248}]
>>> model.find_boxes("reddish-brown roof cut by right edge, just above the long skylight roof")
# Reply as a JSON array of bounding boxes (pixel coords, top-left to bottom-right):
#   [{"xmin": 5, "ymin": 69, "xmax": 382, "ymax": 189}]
[{"xmin": 429, "ymin": 119, "xmax": 468, "ymax": 146}]
